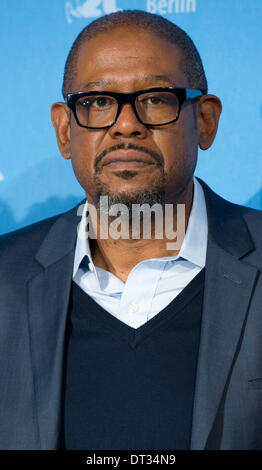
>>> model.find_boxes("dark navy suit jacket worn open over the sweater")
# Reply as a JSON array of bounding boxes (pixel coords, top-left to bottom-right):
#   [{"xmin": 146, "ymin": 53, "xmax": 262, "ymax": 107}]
[{"xmin": 0, "ymin": 178, "xmax": 262, "ymax": 449}]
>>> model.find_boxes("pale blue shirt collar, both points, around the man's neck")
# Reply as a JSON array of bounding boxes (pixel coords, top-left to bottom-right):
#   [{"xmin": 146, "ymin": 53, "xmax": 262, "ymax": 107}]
[{"xmin": 73, "ymin": 178, "xmax": 208, "ymax": 281}]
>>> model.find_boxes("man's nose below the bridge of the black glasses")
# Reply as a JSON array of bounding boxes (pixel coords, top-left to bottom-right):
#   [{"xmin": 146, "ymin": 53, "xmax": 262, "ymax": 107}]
[{"xmin": 108, "ymin": 103, "xmax": 148, "ymax": 139}]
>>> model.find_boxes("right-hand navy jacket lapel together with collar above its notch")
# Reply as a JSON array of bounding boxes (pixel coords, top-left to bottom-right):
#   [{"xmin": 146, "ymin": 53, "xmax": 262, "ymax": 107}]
[{"xmin": 191, "ymin": 181, "xmax": 257, "ymax": 449}]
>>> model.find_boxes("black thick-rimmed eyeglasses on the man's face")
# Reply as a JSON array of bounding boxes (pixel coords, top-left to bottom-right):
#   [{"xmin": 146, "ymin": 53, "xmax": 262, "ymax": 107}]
[{"xmin": 65, "ymin": 88, "xmax": 204, "ymax": 129}]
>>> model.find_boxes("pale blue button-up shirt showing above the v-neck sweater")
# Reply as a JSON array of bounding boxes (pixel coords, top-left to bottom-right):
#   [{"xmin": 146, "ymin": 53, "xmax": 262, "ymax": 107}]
[{"xmin": 73, "ymin": 178, "xmax": 208, "ymax": 328}]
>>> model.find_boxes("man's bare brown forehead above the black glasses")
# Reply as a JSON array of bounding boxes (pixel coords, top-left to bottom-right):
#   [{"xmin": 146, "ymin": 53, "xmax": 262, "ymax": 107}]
[{"xmin": 73, "ymin": 27, "xmax": 188, "ymax": 92}]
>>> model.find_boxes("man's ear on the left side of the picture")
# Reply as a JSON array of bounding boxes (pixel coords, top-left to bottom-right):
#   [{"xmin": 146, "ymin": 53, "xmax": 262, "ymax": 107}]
[{"xmin": 51, "ymin": 102, "xmax": 71, "ymax": 159}]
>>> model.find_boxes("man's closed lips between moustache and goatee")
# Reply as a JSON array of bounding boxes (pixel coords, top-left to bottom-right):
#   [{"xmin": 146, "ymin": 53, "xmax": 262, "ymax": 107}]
[{"xmin": 102, "ymin": 150, "xmax": 156, "ymax": 170}]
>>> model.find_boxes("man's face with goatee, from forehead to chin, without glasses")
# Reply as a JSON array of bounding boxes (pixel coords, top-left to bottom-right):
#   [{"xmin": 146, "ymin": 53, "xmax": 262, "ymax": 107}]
[{"xmin": 58, "ymin": 27, "xmax": 201, "ymax": 204}]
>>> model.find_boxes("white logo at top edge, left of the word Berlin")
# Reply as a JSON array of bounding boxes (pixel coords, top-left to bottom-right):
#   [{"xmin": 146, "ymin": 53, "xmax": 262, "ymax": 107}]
[{"xmin": 65, "ymin": 0, "xmax": 121, "ymax": 23}]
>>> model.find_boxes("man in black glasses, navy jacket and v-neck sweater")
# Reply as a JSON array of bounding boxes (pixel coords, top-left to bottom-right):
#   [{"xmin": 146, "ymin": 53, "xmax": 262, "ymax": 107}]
[{"xmin": 0, "ymin": 11, "xmax": 262, "ymax": 449}]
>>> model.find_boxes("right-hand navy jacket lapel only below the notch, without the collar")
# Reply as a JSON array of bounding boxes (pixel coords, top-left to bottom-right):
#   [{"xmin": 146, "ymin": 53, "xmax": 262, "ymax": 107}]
[{"xmin": 191, "ymin": 242, "xmax": 257, "ymax": 449}]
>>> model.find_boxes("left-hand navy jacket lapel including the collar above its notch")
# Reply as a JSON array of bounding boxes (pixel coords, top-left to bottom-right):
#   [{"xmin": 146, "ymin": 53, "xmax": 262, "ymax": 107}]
[{"xmin": 28, "ymin": 200, "xmax": 84, "ymax": 450}]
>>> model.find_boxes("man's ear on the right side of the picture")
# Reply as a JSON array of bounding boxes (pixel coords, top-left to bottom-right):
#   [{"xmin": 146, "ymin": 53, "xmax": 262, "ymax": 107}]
[{"xmin": 197, "ymin": 95, "xmax": 222, "ymax": 150}]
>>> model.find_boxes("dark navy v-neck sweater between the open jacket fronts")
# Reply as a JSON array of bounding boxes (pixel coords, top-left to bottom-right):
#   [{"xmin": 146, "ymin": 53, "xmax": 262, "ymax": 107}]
[{"xmin": 61, "ymin": 269, "xmax": 204, "ymax": 450}]
